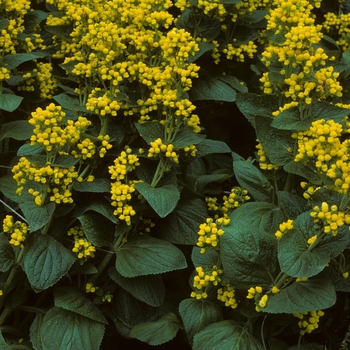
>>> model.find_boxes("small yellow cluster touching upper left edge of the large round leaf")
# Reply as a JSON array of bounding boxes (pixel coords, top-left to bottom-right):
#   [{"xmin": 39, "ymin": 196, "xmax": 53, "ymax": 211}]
[{"xmin": 197, "ymin": 217, "xmax": 230, "ymax": 253}]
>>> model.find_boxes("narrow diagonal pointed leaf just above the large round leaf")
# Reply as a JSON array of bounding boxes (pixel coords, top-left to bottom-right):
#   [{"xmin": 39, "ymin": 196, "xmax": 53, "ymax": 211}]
[{"xmin": 233, "ymin": 160, "xmax": 272, "ymax": 202}]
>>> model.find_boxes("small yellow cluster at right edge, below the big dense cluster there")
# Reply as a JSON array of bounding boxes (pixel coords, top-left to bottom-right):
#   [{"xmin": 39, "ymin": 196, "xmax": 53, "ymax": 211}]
[{"xmin": 309, "ymin": 202, "xmax": 350, "ymax": 235}]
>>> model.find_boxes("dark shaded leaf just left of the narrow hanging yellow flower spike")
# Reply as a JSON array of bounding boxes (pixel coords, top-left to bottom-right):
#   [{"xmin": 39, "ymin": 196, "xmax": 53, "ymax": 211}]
[{"xmin": 78, "ymin": 211, "xmax": 115, "ymax": 247}]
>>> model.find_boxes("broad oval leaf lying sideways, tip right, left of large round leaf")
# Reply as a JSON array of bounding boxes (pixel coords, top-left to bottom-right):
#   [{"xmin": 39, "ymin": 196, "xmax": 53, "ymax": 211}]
[{"xmin": 115, "ymin": 236, "xmax": 187, "ymax": 277}]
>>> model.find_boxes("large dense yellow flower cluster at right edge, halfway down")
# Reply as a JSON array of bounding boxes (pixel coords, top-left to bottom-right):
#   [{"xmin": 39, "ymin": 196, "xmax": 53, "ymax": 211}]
[{"xmin": 292, "ymin": 119, "xmax": 350, "ymax": 193}]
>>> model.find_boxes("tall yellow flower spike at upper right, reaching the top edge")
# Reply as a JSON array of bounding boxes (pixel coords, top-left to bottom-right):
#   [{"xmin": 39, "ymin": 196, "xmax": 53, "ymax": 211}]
[{"xmin": 260, "ymin": 0, "xmax": 342, "ymax": 118}]
